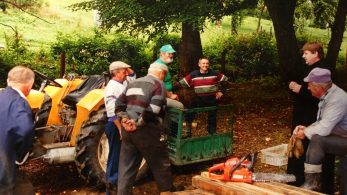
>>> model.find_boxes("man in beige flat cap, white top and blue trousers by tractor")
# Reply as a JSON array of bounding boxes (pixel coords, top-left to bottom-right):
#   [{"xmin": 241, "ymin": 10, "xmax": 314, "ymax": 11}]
[{"xmin": 104, "ymin": 61, "xmax": 136, "ymax": 194}]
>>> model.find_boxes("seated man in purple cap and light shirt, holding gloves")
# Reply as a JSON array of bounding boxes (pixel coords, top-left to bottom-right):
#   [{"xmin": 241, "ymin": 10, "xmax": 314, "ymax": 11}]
[{"xmin": 294, "ymin": 68, "xmax": 347, "ymax": 194}]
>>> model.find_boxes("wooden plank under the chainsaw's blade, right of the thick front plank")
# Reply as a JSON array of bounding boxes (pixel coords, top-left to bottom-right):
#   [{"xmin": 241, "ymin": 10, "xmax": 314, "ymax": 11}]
[{"xmin": 253, "ymin": 182, "xmax": 322, "ymax": 195}]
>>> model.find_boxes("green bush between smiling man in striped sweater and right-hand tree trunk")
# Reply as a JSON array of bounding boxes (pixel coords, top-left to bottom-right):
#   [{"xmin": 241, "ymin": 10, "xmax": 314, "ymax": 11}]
[{"xmin": 204, "ymin": 32, "xmax": 279, "ymax": 80}]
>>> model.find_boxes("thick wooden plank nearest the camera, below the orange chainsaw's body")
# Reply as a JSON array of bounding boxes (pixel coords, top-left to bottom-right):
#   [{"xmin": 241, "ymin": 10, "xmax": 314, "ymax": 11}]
[{"xmin": 192, "ymin": 175, "xmax": 281, "ymax": 195}]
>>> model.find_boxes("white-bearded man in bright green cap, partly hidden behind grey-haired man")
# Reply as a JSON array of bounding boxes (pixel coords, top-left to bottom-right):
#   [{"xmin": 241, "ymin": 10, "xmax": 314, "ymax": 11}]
[{"xmin": 155, "ymin": 44, "xmax": 184, "ymax": 109}]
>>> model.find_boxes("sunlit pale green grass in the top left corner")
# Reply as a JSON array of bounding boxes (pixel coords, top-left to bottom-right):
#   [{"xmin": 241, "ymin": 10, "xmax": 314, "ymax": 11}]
[{"xmin": 0, "ymin": 0, "xmax": 94, "ymax": 50}]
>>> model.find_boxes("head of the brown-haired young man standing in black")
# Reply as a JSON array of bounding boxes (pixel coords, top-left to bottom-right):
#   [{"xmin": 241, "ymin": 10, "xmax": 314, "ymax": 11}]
[{"xmin": 301, "ymin": 42, "xmax": 324, "ymax": 65}]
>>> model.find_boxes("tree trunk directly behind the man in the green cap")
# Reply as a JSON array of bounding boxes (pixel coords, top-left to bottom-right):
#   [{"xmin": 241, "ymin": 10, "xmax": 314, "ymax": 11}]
[{"xmin": 179, "ymin": 23, "xmax": 202, "ymax": 77}]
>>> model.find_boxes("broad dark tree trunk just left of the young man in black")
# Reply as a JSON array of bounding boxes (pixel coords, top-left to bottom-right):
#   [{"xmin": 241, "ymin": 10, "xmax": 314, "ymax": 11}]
[{"xmin": 264, "ymin": 0, "xmax": 303, "ymax": 81}]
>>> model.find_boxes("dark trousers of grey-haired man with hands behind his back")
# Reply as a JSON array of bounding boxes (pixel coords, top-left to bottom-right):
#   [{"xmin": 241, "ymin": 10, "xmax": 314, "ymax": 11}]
[{"xmin": 117, "ymin": 123, "xmax": 173, "ymax": 195}]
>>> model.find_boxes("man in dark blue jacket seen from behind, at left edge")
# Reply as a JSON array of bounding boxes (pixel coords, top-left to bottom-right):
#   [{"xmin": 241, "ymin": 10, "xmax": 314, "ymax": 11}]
[{"xmin": 0, "ymin": 66, "xmax": 35, "ymax": 195}]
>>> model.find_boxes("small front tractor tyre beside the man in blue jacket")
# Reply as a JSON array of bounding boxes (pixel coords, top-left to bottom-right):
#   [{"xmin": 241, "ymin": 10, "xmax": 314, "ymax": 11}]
[{"xmin": 35, "ymin": 94, "xmax": 52, "ymax": 128}]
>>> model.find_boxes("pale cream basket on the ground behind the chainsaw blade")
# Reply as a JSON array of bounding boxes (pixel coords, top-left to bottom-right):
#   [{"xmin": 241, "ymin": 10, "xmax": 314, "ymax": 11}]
[{"xmin": 261, "ymin": 144, "xmax": 288, "ymax": 166}]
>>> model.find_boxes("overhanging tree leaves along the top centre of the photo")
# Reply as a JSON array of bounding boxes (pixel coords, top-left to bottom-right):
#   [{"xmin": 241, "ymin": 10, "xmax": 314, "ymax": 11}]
[{"xmin": 71, "ymin": 0, "xmax": 257, "ymax": 38}]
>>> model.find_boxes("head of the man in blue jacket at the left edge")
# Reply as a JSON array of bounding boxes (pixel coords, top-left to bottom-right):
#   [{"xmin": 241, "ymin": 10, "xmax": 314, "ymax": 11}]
[{"xmin": 7, "ymin": 66, "xmax": 35, "ymax": 96}]
